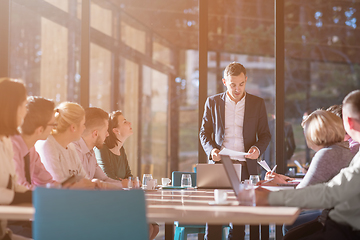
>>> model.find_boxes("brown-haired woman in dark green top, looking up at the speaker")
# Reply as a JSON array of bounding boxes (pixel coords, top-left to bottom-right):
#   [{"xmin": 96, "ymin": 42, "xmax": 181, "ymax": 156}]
[{"xmin": 95, "ymin": 111, "xmax": 133, "ymax": 186}]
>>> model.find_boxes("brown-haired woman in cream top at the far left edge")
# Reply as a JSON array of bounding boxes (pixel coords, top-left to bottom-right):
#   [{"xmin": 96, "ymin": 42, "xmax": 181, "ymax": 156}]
[{"xmin": 0, "ymin": 78, "xmax": 32, "ymax": 239}]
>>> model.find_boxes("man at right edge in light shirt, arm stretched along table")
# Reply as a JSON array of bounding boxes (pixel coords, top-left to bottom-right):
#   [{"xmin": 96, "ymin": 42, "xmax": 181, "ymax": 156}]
[{"xmin": 255, "ymin": 90, "xmax": 360, "ymax": 240}]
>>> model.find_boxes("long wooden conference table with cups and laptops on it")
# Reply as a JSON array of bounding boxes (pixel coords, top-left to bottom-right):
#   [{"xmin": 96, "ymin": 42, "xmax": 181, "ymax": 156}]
[{"xmin": 0, "ymin": 189, "xmax": 300, "ymax": 239}]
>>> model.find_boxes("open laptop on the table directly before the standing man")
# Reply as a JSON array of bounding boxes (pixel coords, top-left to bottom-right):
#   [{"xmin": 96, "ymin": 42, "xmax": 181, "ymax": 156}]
[{"xmin": 196, "ymin": 163, "xmax": 241, "ymax": 189}]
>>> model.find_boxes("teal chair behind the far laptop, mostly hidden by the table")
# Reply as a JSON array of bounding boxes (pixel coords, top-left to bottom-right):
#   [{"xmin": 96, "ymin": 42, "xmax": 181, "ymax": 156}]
[{"xmin": 171, "ymin": 171, "xmax": 229, "ymax": 240}]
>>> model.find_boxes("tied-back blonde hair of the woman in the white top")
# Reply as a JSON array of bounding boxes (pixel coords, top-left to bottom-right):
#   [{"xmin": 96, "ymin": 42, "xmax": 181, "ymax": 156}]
[{"xmin": 52, "ymin": 102, "xmax": 85, "ymax": 134}]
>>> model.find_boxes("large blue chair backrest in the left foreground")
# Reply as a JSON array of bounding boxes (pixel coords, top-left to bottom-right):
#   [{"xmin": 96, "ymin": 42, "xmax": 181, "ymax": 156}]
[{"xmin": 33, "ymin": 188, "xmax": 149, "ymax": 240}]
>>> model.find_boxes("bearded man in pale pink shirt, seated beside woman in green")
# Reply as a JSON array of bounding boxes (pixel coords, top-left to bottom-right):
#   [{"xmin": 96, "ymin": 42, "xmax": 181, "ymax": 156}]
[{"xmin": 73, "ymin": 107, "xmax": 122, "ymax": 187}]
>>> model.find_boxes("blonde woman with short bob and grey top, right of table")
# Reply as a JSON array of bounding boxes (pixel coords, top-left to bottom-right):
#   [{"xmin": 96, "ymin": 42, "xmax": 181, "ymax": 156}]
[{"xmin": 266, "ymin": 110, "xmax": 354, "ymax": 188}]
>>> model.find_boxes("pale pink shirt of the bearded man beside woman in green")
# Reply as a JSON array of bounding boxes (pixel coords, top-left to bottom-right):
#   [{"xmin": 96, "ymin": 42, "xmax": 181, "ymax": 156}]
[{"xmin": 73, "ymin": 138, "xmax": 122, "ymax": 187}]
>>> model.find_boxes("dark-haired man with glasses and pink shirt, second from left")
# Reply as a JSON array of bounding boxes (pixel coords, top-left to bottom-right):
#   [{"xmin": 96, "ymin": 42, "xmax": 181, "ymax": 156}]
[{"xmin": 11, "ymin": 97, "xmax": 56, "ymax": 189}]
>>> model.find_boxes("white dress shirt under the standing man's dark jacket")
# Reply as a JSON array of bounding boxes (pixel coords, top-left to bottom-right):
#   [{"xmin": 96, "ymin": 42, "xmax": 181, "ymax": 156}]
[{"xmin": 222, "ymin": 93, "xmax": 246, "ymax": 161}]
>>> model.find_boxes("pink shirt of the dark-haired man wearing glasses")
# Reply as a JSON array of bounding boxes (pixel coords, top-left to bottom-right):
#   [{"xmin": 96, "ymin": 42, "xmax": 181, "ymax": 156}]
[{"xmin": 11, "ymin": 135, "xmax": 55, "ymax": 189}]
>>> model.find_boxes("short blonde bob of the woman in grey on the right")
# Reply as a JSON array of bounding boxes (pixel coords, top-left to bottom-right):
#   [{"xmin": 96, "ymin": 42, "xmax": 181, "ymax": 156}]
[{"xmin": 301, "ymin": 110, "xmax": 345, "ymax": 147}]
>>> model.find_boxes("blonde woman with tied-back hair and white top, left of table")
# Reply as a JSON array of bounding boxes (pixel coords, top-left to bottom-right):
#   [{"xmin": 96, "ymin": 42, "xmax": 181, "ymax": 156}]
[{"xmin": 35, "ymin": 102, "xmax": 90, "ymax": 182}]
